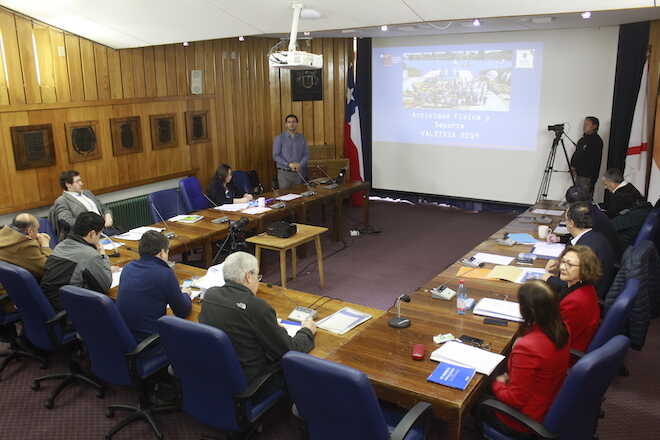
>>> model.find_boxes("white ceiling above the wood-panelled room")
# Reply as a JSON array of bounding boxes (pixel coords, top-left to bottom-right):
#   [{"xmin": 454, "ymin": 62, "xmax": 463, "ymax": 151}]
[{"xmin": 0, "ymin": 0, "xmax": 660, "ymax": 48}]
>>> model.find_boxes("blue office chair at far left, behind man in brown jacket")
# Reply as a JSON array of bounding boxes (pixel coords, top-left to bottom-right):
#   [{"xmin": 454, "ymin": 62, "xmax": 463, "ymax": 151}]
[{"xmin": 0, "ymin": 261, "xmax": 104, "ymax": 409}]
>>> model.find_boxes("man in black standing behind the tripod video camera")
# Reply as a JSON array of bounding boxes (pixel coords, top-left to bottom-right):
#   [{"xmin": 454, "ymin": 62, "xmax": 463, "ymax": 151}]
[{"xmin": 571, "ymin": 116, "xmax": 603, "ymax": 194}]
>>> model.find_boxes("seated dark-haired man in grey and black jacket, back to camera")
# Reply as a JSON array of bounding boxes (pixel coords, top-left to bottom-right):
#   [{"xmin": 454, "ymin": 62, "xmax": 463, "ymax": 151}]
[{"xmin": 41, "ymin": 211, "xmax": 116, "ymax": 312}]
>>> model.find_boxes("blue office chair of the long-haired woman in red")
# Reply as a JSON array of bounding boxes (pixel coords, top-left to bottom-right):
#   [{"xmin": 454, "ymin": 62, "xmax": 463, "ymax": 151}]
[{"xmin": 478, "ymin": 335, "xmax": 630, "ymax": 440}]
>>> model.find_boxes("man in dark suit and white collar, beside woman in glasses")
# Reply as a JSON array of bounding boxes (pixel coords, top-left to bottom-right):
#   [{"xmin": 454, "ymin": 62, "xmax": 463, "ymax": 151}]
[{"xmin": 546, "ymin": 202, "xmax": 616, "ymax": 299}]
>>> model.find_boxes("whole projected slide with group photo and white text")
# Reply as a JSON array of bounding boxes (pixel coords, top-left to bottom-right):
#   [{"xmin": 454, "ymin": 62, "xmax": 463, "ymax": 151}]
[{"xmin": 372, "ymin": 42, "xmax": 543, "ymax": 150}]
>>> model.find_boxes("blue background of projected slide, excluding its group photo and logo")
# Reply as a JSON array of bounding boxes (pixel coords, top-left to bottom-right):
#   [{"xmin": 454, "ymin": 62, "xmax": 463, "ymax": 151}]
[{"xmin": 372, "ymin": 42, "xmax": 543, "ymax": 151}]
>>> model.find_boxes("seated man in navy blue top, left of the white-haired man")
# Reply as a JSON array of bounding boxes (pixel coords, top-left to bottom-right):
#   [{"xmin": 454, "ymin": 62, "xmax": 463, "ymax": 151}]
[{"xmin": 117, "ymin": 231, "xmax": 192, "ymax": 343}]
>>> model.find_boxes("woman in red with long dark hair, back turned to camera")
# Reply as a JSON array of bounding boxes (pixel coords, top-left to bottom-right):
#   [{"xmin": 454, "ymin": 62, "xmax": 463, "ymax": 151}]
[{"xmin": 489, "ymin": 280, "xmax": 570, "ymax": 439}]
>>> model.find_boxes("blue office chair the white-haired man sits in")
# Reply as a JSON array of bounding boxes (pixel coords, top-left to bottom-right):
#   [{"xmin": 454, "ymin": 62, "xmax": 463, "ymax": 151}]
[{"xmin": 158, "ymin": 316, "xmax": 284, "ymax": 438}]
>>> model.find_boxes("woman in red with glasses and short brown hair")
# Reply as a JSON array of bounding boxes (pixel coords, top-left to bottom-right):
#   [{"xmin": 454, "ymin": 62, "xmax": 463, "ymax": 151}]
[{"xmin": 546, "ymin": 246, "xmax": 601, "ymax": 352}]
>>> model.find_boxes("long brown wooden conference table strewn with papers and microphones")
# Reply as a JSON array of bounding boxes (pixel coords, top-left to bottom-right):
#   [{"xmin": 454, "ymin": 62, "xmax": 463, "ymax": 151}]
[{"xmin": 112, "ymin": 195, "xmax": 560, "ymax": 439}]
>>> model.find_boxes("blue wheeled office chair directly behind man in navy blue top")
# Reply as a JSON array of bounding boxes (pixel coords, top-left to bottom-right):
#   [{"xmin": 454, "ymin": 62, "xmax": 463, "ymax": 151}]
[{"xmin": 60, "ymin": 286, "xmax": 177, "ymax": 439}]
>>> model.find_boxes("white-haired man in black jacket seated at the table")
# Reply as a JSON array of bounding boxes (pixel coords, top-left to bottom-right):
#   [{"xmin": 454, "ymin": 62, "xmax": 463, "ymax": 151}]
[{"xmin": 199, "ymin": 252, "xmax": 316, "ymax": 398}]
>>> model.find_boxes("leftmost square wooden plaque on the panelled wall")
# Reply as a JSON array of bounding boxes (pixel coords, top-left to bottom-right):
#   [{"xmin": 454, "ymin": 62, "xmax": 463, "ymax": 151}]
[{"xmin": 10, "ymin": 124, "xmax": 55, "ymax": 170}]
